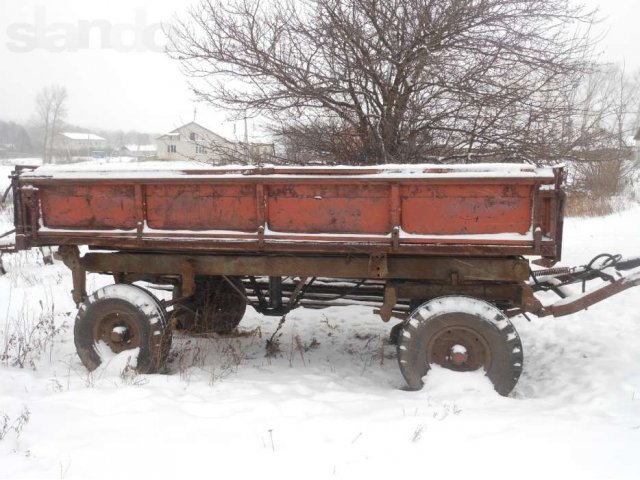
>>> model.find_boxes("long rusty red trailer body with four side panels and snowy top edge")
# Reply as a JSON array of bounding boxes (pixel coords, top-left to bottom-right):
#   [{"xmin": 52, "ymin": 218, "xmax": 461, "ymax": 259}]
[{"xmin": 10, "ymin": 165, "xmax": 562, "ymax": 260}]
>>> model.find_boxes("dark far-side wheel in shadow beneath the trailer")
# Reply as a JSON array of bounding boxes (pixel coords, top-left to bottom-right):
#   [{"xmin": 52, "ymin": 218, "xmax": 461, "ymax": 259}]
[{"xmin": 182, "ymin": 277, "xmax": 247, "ymax": 334}]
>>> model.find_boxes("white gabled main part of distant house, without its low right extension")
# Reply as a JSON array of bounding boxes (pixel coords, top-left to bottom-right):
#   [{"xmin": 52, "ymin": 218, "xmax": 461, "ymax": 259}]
[{"xmin": 156, "ymin": 122, "xmax": 235, "ymax": 162}]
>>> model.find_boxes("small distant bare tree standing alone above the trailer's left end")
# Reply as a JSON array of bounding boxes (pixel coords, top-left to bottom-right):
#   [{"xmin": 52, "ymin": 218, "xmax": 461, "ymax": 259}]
[{"xmin": 36, "ymin": 85, "xmax": 67, "ymax": 163}]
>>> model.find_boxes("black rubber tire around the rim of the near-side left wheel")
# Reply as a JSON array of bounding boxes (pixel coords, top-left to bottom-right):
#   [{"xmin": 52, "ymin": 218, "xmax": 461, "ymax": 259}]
[{"xmin": 74, "ymin": 284, "xmax": 171, "ymax": 373}]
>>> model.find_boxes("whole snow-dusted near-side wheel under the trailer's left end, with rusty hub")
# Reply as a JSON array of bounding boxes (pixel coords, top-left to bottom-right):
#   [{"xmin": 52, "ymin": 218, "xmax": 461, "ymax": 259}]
[{"xmin": 74, "ymin": 284, "xmax": 171, "ymax": 373}]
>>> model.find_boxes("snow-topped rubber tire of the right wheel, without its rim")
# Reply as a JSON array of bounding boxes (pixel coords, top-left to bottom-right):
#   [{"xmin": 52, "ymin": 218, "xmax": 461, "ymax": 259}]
[{"xmin": 397, "ymin": 296, "xmax": 523, "ymax": 396}]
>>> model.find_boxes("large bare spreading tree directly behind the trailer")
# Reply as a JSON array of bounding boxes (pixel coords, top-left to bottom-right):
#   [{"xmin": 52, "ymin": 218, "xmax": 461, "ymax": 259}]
[{"xmin": 169, "ymin": 0, "xmax": 593, "ymax": 163}]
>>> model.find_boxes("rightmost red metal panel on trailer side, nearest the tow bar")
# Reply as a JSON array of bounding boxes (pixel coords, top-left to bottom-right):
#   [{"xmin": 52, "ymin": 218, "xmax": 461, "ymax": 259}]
[{"xmin": 401, "ymin": 184, "xmax": 533, "ymax": 235}]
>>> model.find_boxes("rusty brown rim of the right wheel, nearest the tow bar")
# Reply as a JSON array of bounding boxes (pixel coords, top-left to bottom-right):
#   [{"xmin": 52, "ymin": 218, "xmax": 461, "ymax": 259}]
[{"xmin": 427, "ymin": 326, "xmax": 491, "ymax": 372}]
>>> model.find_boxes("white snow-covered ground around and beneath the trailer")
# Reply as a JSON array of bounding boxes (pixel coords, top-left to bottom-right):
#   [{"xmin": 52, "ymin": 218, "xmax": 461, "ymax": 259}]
[{"xmin": 0, "ymin": 160, "xmax": 640, "ymax": 479}]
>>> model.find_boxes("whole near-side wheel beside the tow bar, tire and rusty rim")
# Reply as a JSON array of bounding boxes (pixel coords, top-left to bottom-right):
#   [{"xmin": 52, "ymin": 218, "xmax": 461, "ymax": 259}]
[{"xmin": 397, "ymin": 296, "xmax": 523, "ymax": 396}]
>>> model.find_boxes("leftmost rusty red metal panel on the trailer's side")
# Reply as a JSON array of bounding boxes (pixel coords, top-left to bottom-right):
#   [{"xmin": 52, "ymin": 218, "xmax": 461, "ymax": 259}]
[{"xmin": 40, "ymin": 185, "xmax": 136, "ymax": 230}]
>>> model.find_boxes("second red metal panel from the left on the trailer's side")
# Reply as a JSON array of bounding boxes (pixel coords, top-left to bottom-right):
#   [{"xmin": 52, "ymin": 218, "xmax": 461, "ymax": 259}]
[{"xmin": 146, "ymin": 184, "xmax": 258, "ymax": 232}]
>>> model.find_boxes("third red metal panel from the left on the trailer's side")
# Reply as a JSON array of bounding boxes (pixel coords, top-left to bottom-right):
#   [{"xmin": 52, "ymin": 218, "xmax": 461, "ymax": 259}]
[{"xmin": 267, "ymin": 183, "xmax": 391, "ymax": 234}]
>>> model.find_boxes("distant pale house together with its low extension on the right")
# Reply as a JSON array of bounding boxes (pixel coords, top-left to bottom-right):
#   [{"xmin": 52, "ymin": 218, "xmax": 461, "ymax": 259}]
[{"xmin": 156, "ymin": 122, "xmax": 275, "ymax": 163}]
